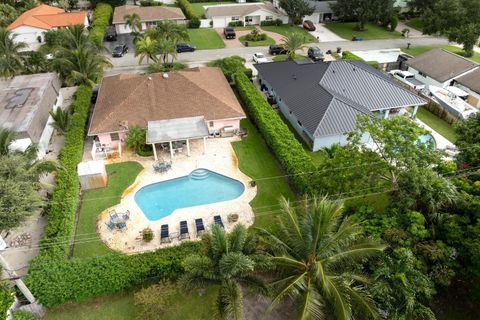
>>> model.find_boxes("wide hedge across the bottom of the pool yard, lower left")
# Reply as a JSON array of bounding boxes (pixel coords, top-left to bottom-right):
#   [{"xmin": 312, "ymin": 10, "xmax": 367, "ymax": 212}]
[{"xmin": 25, "ymin": 242, "xmax": 202, "ymax": 307}]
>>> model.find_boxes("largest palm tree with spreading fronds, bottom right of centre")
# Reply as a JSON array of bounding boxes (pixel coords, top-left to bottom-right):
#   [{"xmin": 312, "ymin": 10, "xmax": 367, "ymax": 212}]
[{"xmin": 260, "ymin": 197, "xmax": 385, "ymax": 320}]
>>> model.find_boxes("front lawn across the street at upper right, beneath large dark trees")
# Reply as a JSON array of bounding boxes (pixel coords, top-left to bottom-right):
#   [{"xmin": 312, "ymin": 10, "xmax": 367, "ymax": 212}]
[{"xmin": 325, "ymin": 22, "xmax": 402, "ymax": 40}]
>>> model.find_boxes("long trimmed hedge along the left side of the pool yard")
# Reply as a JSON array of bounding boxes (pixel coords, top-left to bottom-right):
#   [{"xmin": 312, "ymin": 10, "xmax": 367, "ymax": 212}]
[{"xmin": 41, "ymin": 85, "xmax": 92, "ymax": 258}]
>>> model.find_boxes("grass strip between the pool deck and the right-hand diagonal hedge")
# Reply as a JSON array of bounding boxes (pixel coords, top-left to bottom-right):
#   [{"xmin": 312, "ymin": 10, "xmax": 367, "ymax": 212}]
[{"xmin": 232, "ymin": 119, "xmax": 295, "ymax": 228}]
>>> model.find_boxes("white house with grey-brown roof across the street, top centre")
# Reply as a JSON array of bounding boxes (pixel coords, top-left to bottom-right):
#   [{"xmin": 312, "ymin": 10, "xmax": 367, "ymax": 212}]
[{"xmin": 204, "ymin": 2, "xmax": 288, "ymax": 28}]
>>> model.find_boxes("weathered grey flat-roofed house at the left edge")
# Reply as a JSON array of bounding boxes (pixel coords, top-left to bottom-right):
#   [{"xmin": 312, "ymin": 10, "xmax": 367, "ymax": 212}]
[{"xmin": 0, "ymin": 73, "xmax": 63, "ymax": 158}]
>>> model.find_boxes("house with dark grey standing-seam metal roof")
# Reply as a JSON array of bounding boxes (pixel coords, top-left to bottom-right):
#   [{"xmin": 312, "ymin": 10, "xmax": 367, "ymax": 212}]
[{"xmin": 255, "ymin": 60, "xmax": 426, "ymax": 151}]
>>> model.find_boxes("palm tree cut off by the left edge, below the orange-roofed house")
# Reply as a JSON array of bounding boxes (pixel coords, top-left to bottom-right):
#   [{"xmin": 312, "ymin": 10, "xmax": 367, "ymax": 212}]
[{"xmin": 0, "ymin": 28, "xmax": 27, "ymax": 78}]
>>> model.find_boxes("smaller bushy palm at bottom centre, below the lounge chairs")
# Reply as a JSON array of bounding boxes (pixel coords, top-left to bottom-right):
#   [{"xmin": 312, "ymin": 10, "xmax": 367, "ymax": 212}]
[{"xmin": 180, "ymin": 224, "xmax": 266, "ymax": 320}]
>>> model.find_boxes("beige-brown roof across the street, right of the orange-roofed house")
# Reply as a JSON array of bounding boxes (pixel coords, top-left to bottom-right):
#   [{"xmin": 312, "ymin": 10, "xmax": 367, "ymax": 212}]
[{"xmin": 112, "ymin": 5, "xmax": 185, "ymax": 24}]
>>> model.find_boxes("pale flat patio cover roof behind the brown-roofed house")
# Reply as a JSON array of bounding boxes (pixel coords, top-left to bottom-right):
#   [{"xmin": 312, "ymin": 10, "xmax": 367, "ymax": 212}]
[{"xmin": 147, "ymin": 117, "xmax": 208, "ymax": 143}]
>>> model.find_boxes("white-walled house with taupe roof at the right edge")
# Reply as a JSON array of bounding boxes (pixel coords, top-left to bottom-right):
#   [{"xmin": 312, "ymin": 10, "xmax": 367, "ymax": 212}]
[{"xmin": 405, "ymin": 48, "xmax": 478, "ymax": 88}]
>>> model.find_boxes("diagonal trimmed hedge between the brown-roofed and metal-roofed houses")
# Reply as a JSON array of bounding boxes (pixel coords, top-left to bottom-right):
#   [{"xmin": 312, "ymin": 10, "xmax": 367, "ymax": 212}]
[{"xmin": 235, "ymin": 72, "xmax": 316, "ymax": 193}]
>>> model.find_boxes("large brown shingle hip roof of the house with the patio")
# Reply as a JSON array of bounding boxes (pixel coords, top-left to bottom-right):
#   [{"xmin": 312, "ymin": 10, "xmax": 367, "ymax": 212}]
[{"xmin": 88, "ymin": 67, "xmax": 245, "ymax": 135}]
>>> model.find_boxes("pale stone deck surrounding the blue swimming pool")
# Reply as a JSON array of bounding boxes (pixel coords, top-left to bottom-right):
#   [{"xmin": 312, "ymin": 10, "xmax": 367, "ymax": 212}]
[{"xmin": 97, "ymin": 137, "xmax": 257, "ymax": 254}]
